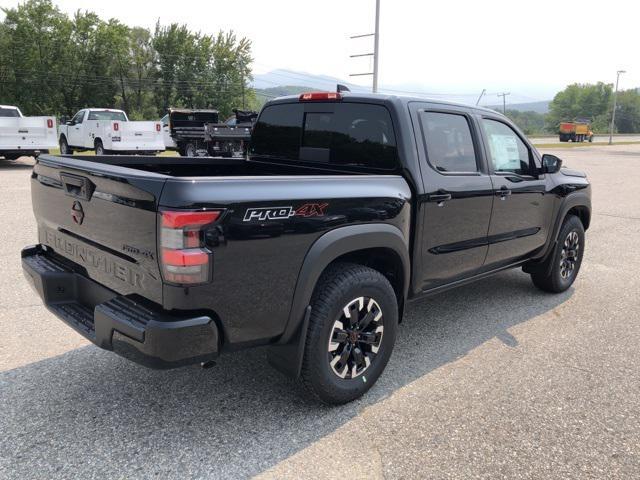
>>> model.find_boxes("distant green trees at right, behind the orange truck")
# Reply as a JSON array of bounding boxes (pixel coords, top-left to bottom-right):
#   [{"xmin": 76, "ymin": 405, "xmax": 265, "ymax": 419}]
[{"xmin": 506, "ymin": 82, "xmax": 640, "ymax": 135}]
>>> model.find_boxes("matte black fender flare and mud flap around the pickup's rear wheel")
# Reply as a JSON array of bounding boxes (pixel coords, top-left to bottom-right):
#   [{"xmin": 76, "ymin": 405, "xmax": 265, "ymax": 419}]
[{"xmin": 267, "ymin": 223, "xmax": 411, "ymax": 378}]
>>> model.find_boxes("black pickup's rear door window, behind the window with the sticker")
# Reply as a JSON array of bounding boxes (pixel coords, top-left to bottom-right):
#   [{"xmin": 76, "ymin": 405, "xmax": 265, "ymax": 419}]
[{"xmin": 420, "ymin": 112, "xmax": 478, "ymax": 173}]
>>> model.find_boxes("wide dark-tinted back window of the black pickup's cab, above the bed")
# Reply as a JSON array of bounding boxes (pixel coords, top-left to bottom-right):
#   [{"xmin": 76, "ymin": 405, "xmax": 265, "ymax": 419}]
[{"xmin": 251, "ymin": 103, "xmax": 398, "ymax": 170}]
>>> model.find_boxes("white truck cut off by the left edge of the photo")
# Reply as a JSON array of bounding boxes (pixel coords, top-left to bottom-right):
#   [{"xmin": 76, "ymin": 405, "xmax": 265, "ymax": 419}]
[{"xmin": 0, "ymin": 105, "xmax": 57, "ymax": 160}]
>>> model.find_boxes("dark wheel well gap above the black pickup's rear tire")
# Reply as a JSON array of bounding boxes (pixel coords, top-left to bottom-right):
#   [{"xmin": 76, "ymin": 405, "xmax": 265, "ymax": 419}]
[{"xmin": 325, "ymin": 247, "xmax": 405, "ymax": 320}]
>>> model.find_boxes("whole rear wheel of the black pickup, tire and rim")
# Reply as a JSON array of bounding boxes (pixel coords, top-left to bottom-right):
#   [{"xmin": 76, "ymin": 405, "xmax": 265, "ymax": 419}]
[{"xmin": 302, "ymin": 263, "xmax": 398, "ymax": 404}]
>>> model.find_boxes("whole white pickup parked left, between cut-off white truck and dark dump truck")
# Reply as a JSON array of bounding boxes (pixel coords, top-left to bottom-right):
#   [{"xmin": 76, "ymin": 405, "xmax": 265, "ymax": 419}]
[{"xmin": 58, "ymin": 108, "xmax": 165, "ymax": 155}]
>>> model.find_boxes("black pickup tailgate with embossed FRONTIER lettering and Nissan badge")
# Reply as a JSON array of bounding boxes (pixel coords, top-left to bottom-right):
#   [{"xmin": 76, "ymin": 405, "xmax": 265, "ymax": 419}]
[{"xmin": 31, "ymin": 155, "xmax": 166, "ymax": 303}]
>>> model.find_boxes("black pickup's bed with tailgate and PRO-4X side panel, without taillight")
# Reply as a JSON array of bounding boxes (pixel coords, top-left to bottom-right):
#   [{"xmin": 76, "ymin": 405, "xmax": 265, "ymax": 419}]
[{"xmin": 31, "ymin": 155, "xmax": 411, "ymax": 345}]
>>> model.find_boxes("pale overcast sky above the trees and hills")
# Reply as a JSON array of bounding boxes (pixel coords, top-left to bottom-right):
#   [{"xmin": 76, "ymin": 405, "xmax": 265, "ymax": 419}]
[{"xmin": 0, "ymin": 0, "xmax": 640, "ymax": 103}]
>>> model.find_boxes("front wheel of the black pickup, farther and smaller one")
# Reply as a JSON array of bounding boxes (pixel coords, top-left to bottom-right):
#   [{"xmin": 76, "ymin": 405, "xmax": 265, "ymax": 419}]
[{"xmin": 531, "ymin": 215, "xmax": 585, "ymax": 293}]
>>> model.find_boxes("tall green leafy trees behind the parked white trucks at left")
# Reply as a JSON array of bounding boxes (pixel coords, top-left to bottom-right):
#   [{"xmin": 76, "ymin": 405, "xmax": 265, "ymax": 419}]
[{"xmin": 0, "ymin": 0, "xmax": 256, "ymax": 119}]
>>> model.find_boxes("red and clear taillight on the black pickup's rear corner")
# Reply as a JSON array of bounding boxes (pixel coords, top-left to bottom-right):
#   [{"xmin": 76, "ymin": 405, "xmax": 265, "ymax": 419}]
[{"xmin": 160, "ymin": 210, "xmax": 221, "ymax": 285}]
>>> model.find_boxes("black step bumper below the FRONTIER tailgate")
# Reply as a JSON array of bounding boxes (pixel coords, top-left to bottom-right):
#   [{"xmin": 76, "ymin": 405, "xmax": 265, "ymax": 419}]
[{"xmin": 22, "ymin": 245, "xmax": 219, "ymax": 369}]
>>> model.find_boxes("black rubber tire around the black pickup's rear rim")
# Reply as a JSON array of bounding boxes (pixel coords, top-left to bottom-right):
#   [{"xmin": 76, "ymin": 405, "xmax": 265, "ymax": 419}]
[{"xmin": 301, "ymin": 263, "xmax": 398, "ymax": 405}]
